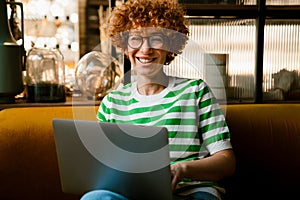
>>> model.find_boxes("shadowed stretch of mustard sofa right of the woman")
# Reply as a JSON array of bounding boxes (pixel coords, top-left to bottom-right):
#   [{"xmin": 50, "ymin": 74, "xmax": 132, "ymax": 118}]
[{"xmin": 223, "ymin": 104, "xmax": 300, "ymax": 199}]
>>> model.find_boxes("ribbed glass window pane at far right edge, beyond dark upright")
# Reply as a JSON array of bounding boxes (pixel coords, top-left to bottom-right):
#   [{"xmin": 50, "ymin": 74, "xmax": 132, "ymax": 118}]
[{"xmin": 263, "ymin": 19, "xmax": 300, "ymax": 101}]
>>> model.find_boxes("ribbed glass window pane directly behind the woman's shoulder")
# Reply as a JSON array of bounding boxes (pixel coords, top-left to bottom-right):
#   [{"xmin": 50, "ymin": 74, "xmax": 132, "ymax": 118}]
[{"xmin": 166, "ymin": 19, "xmax": 256, "ymax": 102}]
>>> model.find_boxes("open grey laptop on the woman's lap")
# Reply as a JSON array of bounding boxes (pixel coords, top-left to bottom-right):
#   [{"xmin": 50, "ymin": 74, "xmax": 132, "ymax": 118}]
[{"xmin": 52, "ymin": 119, "xmax": 172, "ymax": 200}]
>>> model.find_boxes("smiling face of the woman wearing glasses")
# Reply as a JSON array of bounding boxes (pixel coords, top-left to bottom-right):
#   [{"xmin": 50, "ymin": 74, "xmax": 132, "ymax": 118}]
[{"xmin": 126, "ymin": 27, "xmax": 168, "ymax": 78}]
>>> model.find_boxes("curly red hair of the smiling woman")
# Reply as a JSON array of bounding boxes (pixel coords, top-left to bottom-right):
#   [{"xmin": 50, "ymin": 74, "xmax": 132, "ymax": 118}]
[{"xmin": 106, "ymin": 0, "xmax": 189, "ymax": 64}]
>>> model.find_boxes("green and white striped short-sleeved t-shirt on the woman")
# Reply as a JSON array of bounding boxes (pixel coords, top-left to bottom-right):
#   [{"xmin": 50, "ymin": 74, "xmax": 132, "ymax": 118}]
[{"xmin": 97, "ymin": 77, "xmax": 231, "ymax": 195}]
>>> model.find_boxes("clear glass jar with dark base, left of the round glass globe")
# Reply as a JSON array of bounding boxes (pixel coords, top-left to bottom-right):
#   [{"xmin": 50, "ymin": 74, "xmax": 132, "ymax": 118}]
[{"xmin": 25, "ymin": 47, "xmax": 66, "ymax": 103}]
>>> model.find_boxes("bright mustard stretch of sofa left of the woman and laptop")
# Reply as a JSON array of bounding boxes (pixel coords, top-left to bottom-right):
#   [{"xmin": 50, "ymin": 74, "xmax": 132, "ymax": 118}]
[{"xmin": 0, "ymin": 106, "xmax": 96, "ymax": 200}]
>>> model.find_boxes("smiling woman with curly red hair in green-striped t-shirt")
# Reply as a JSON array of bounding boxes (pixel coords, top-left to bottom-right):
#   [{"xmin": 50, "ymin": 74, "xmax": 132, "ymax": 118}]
[{"xmin": 82, "ymin": 0, "xmax": 235, "ymax": 200}]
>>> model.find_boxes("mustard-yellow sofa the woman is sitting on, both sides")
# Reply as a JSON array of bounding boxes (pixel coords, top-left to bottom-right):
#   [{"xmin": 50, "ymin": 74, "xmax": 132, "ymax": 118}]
[{"xmin": 0, "ymin": 104, "xmax": 300, "ymax": 200}]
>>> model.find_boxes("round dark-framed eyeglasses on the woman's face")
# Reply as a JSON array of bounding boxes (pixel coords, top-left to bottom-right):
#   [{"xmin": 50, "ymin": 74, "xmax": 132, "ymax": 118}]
[{"xmin": 128, "ymin": 35, "xmax": 165, "ymax": 49}]
